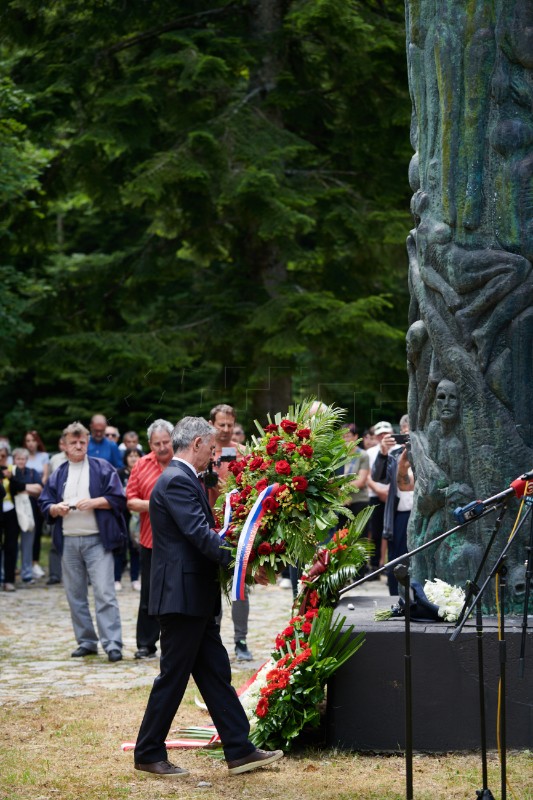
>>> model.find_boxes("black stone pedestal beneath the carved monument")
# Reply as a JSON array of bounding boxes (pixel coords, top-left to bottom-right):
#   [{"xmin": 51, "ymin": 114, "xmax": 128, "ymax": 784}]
[{"xmin": 326, "ymin": 595, "xmax": 533, "ymax": 752}]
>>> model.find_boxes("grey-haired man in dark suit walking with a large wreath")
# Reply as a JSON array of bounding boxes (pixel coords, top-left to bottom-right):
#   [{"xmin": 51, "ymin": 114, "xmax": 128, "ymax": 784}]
[{"xmin": 135, "ymin": 417, "xmax": 283, "ymax": 777}]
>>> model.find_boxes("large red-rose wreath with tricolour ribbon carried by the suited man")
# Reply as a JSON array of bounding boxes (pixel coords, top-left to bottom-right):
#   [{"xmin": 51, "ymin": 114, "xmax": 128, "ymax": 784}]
[{"xmin": 218, "ymin": 400, "xmax": 353, "ymax": 597}]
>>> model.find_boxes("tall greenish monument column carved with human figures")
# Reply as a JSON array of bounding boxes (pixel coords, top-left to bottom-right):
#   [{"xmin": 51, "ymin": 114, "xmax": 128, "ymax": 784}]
[{"xmin": 406, "ymin": 0, "xmax": 533, "ymax": 610}]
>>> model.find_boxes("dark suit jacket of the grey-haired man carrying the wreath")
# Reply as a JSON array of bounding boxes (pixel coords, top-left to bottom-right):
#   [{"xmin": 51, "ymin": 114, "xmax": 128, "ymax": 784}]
[{"xmin": 148, "ymin": 460, "xmax": 231, "ymax": 617}]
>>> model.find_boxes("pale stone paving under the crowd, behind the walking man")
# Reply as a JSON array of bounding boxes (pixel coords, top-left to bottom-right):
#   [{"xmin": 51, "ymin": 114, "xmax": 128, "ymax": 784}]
[{"xmin": 0, "ymin": 578, "xmax": 388, "ymax": 705}]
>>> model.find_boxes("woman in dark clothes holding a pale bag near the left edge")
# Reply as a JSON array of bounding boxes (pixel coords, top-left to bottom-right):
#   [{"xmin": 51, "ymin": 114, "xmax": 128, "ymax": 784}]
[{"xmin": 11, "ymin": 447, "xmax": 43, "ymax": 583}]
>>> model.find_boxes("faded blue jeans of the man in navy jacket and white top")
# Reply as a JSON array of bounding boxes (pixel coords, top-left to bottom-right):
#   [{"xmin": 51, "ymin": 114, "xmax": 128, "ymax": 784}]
[{"xmin": 61, "ymin": 534, "xmax": 122, "ymax": 653}]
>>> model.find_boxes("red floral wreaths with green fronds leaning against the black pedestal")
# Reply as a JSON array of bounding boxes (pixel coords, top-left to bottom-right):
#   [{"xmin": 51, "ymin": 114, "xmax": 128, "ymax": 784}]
[{"xmin": 240, "ymin": 510, "xmax": 371, "ymax": 749}]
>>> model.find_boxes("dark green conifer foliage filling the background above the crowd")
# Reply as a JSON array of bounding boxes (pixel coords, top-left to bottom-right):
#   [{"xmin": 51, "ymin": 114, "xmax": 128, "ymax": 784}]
[{"xmin": 0, "ymin": 0, "xmax": 410, "ymax": 440}]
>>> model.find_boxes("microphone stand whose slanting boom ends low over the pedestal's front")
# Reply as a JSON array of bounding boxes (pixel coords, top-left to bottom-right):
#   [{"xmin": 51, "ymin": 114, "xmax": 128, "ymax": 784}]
[{"xmin": 450, "ymin": 501, "xmax": 533, "ymax": 800}]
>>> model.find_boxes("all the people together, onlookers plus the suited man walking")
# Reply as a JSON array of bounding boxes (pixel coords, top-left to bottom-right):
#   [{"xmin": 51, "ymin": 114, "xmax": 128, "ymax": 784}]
[{"xmin": 0, "ymin": 404, "xmax": 413, "ymax": 777}]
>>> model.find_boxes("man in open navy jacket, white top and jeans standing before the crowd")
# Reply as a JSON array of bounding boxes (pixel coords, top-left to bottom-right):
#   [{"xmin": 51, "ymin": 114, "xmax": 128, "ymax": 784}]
[{"xmin": 39, "ymin": 422, "xmax": 127, "ymax": 662}]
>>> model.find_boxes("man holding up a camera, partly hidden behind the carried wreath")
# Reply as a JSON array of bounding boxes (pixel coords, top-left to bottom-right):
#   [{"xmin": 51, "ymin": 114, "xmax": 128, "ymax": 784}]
[{"xmin": 202, "ymin": 403, "xmax": 253, "ymax": 661}]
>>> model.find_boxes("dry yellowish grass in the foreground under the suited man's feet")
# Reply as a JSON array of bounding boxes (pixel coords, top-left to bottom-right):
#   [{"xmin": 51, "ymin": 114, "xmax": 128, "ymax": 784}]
[{"xmin": 0, "ymin": 685, "xmax": 533, "ymax": 800}]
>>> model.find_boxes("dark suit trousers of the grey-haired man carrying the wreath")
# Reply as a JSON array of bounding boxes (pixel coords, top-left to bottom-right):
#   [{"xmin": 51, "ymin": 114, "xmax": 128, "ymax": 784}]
[{"xmin": 135, "ymin": 614, "xmax": 255, "ymax": 764}]
